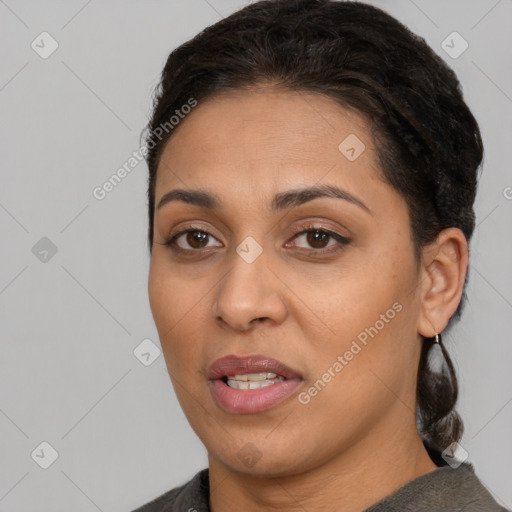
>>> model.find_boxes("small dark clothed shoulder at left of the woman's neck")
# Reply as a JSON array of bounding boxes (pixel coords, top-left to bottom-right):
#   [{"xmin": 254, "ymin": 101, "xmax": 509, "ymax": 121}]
[{"xmin": 133, "ymin": 468, "xmax": 209, "ymax": 512}]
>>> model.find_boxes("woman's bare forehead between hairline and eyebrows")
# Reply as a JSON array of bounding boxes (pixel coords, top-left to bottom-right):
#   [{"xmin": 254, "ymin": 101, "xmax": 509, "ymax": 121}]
[{"xmin": 156, "ymin": 88, "xmax": 380, "ymax": 200}]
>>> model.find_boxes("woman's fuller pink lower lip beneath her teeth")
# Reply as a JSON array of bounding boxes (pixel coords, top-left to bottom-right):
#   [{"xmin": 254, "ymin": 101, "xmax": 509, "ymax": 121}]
[{"xmin": 210, "ymin": 379, "xmax": 302, "ymax": 413}]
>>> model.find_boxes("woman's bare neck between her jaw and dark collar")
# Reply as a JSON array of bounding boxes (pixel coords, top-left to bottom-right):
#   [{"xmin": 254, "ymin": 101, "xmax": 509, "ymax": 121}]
[{"xmin": 209, "ymin": 425, "xmax": 437, "ymax": 512}]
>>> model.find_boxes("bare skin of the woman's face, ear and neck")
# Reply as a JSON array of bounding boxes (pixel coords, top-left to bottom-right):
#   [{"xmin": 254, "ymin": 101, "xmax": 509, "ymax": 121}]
[{"xmin": 149, "ymin": 86, "xmax": 467, "ymax": 512}]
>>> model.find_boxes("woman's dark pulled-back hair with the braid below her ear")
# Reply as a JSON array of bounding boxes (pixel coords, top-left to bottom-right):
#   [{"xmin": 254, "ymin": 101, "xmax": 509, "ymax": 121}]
[{"xmin": 146, "ymin": 0, "xmax": 483, "ymax": 465}]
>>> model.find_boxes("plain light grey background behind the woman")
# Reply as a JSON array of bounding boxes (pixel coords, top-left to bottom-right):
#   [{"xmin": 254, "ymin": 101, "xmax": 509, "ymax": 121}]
[{"xmin": 0, "ymin": 0, "xmax": 512, "ymax": 512}]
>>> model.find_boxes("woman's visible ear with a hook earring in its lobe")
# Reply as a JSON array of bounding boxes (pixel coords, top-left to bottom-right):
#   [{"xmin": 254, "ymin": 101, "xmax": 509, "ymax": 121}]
[{"xmin": 418, "ymin": 228, "xmax": 468, "ymax": 338}]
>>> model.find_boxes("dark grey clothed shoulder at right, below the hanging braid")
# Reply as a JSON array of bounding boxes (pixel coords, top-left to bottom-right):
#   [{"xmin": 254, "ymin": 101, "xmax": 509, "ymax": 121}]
[{"xmin": 366, "ymin": 463, "xmax": 507, "ymax": 512}]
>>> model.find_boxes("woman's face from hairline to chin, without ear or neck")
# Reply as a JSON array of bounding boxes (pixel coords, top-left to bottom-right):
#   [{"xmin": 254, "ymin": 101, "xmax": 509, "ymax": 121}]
[{"xmin": 149, "ymin": 89, "xmax": 428, "ymax": 475}]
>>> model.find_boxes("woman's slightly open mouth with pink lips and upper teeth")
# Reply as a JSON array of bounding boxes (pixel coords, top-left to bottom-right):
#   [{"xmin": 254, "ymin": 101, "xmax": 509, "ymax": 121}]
[{"xmin": 208, "ymin": 355, "xmax": 303, "ymax": 414}]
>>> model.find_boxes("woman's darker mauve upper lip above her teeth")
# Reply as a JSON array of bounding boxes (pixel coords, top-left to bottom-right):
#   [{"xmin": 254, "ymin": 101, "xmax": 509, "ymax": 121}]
[{"xmin": 208, "ymin": 354, "xmax": 300, "ymax": 380}]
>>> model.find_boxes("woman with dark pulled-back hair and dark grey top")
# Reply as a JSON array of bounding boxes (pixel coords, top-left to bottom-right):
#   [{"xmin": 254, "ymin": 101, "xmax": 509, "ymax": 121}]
[{"xmin": 133, "ymin": 0, "xmax": 504, "ymax": 512}]
